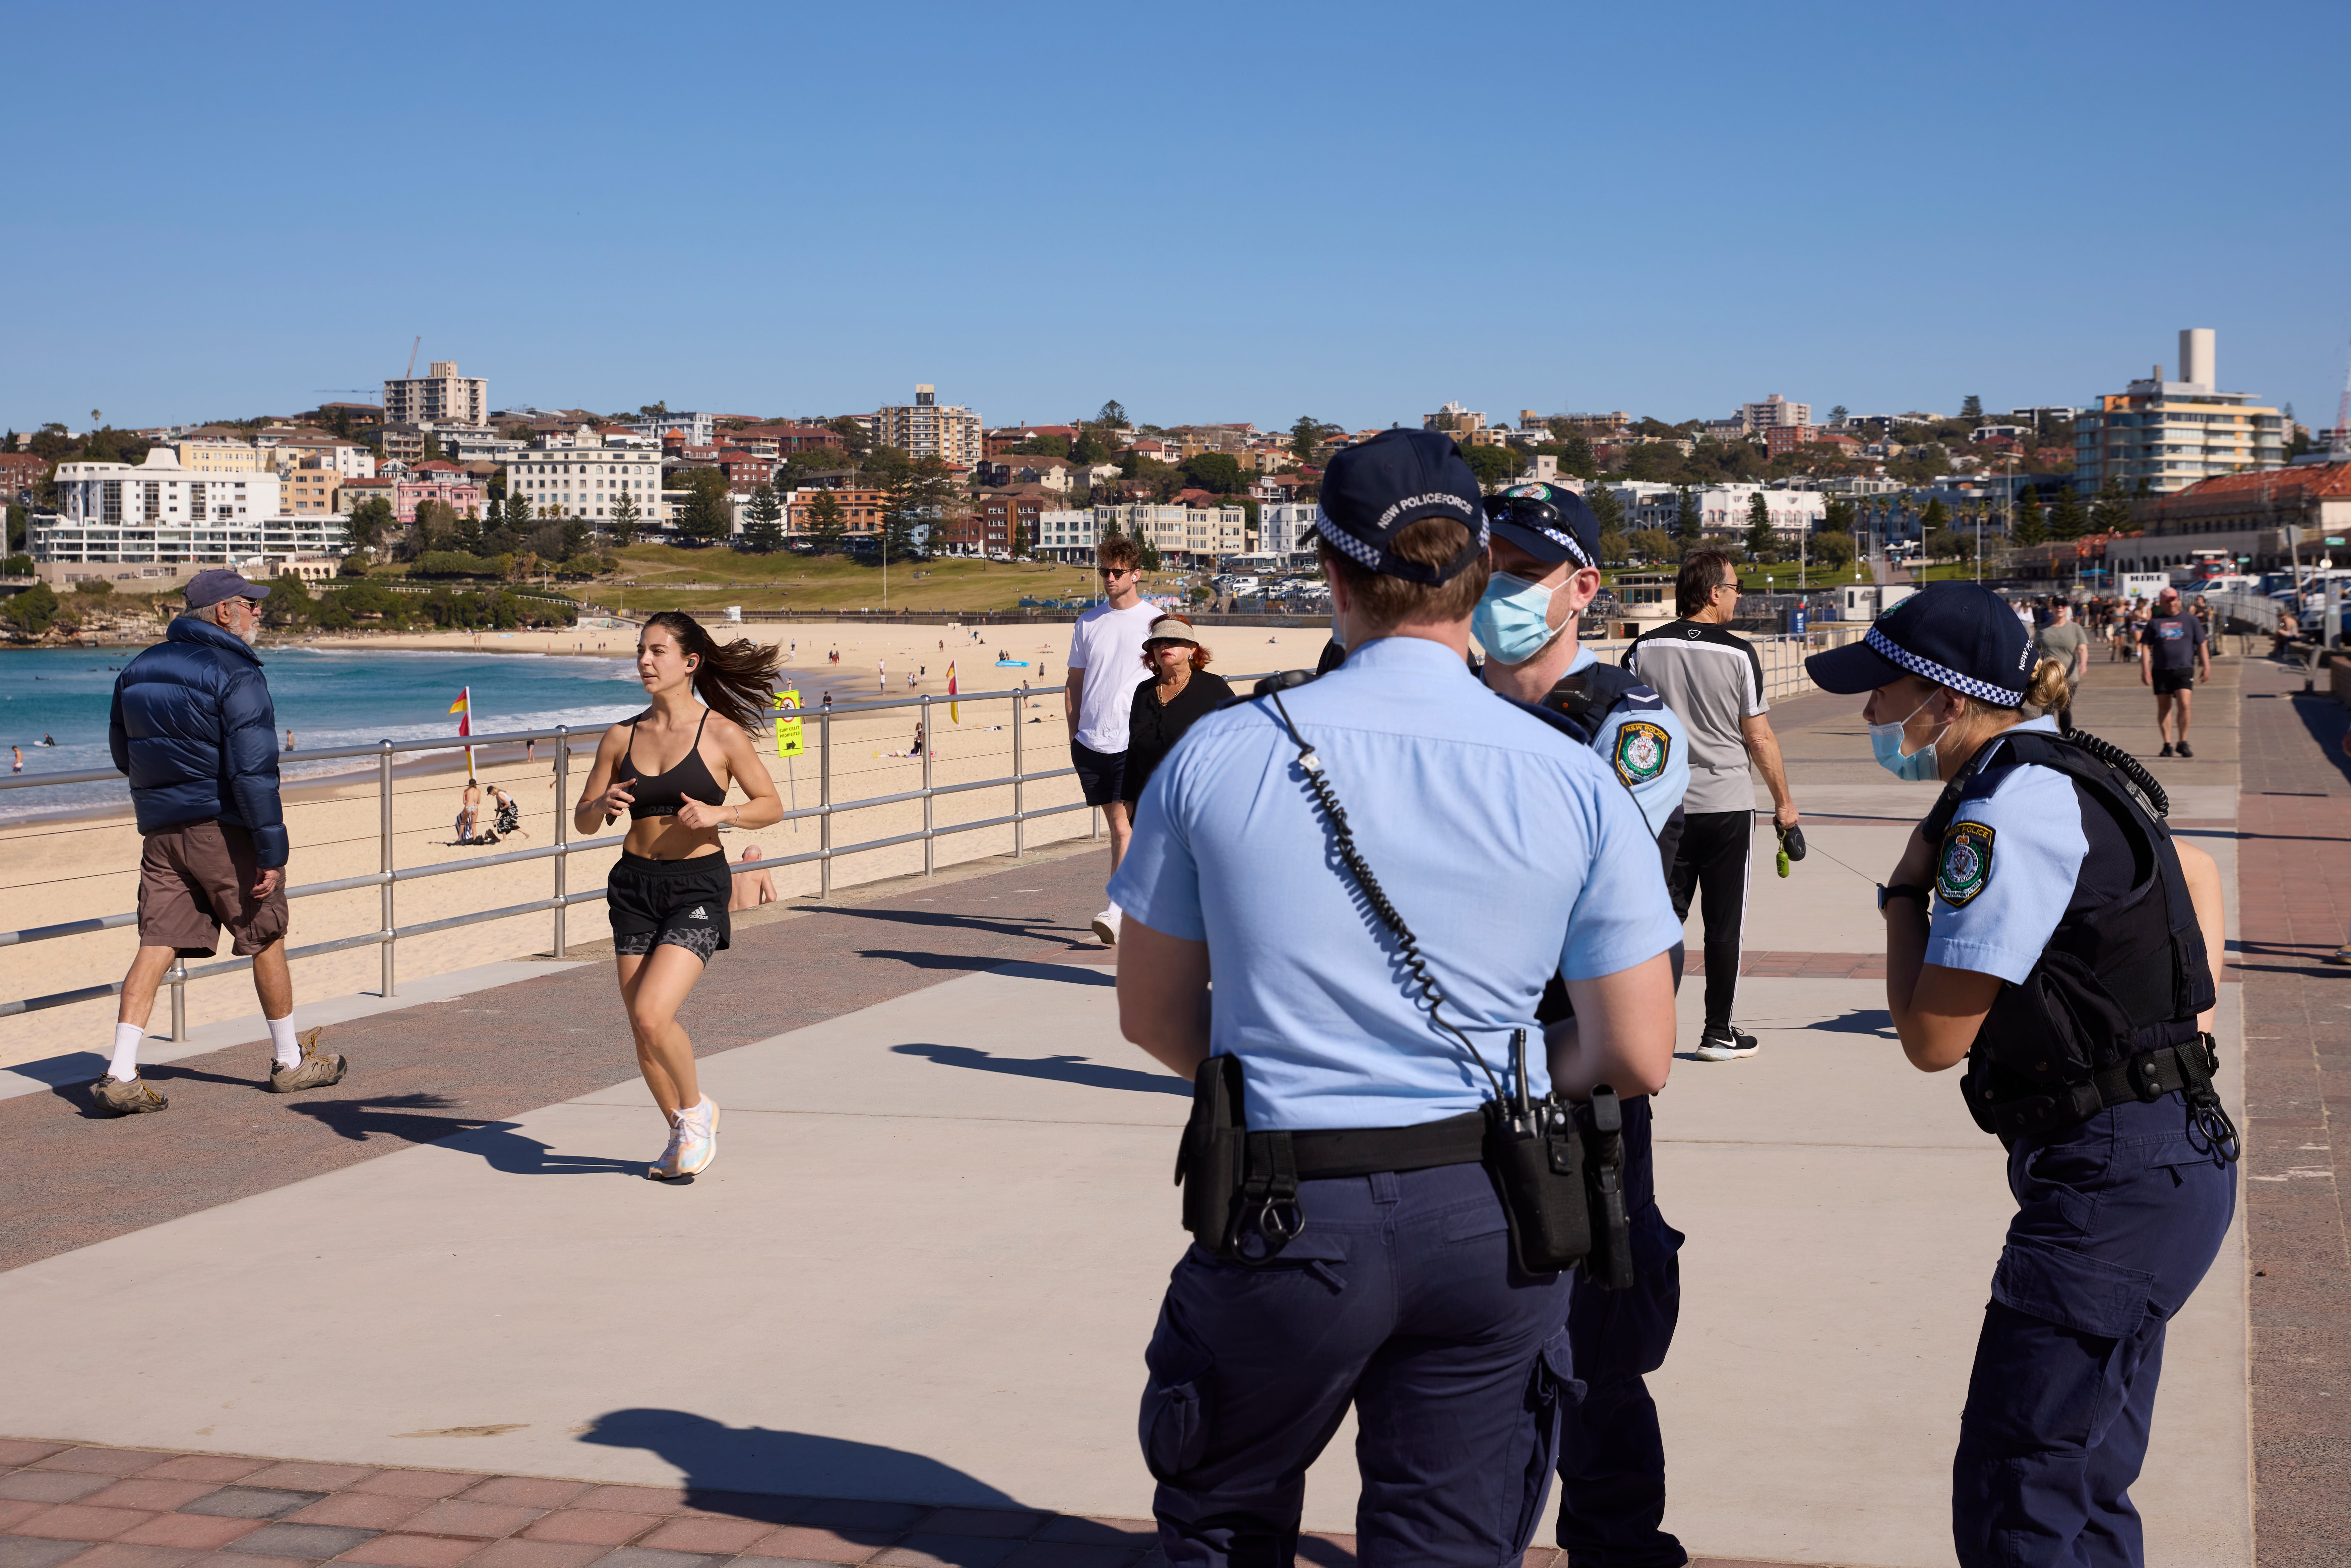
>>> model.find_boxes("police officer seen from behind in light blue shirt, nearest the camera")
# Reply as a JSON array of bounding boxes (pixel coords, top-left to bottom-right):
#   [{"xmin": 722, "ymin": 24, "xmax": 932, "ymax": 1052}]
[{"xmin": 1110, "ymin": 430, "xmax": 1681, "ymax": 1568}]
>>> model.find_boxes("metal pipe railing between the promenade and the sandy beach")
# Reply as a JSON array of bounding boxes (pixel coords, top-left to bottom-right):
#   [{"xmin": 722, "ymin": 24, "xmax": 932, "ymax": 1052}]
[{"xmin": 0, "ymin": 677, "xmax": 1105, "ymax": 1042}]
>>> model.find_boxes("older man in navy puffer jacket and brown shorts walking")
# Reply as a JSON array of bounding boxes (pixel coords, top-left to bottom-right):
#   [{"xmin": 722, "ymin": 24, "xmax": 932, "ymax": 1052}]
[{"xmin": 92, "ymin": 569, "xmax": 346, "ymax": 1117}]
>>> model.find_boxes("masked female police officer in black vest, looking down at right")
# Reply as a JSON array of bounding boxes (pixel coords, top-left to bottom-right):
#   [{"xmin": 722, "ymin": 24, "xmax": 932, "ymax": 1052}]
[{"xmin": 1806, "ymin": 583, "xmax": 2236, "ymax": 1568}]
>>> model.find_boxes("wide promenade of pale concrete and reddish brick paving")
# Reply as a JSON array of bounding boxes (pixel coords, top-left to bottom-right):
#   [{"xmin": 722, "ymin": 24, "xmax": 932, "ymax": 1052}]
[{"xmin": 0, "ymin": 644, "xmax": 2351, "ymax": 1568}]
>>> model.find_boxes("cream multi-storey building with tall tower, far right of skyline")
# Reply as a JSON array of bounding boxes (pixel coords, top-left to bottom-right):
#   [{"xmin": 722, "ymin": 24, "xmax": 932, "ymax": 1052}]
[{"xmin": 2074, "ymin": 327, "xmax": 2288, "ymax": 496}]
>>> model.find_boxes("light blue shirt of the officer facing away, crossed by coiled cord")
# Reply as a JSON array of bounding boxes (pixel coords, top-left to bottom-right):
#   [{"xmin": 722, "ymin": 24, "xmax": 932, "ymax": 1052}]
[{"xmin": 1110, "ymin": 637, "xmax": 1681, "ymax": 1131}]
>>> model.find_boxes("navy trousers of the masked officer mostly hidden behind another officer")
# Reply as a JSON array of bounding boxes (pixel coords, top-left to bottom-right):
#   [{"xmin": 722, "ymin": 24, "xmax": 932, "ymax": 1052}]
[{"xmin": 1559, "ymin": 1095, "xmax": 1690, "ymax": 1568}]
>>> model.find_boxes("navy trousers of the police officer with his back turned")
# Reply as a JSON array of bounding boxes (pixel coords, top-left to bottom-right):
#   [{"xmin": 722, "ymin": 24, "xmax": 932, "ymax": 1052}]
[{"xmin": 1140, "ymin": 1166, "xmax": 1580, "ymax": 1568}]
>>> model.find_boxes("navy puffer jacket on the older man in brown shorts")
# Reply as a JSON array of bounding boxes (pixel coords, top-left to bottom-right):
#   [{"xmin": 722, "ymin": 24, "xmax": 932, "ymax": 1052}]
[{"xmin": 108, "ymin": 616, "xmax": 287, "ymax": 870}]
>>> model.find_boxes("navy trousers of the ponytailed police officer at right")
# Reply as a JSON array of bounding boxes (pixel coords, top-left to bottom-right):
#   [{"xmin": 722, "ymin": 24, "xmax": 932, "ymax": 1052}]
[{"xmin": 1951, "ymin": 1093, "xmax": 2236, "ymax": 1568}]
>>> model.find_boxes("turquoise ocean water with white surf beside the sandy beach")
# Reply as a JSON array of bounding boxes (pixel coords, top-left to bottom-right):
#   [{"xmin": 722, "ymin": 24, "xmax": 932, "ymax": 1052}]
[{"xmin": 0, "ymin": 646, "xmax": 856, "ymax": 820}]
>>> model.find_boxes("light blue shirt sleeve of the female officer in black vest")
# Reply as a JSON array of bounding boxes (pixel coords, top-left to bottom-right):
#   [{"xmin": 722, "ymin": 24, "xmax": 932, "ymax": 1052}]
[{"xmin": 1925, "ymin": 717, "xmax": 2090, "ymax": 985}]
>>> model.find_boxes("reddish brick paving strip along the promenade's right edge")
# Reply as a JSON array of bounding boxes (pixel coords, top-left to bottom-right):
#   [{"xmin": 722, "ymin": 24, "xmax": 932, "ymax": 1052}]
[{"xmin": 2233, "ymin": 661, "xmax": 2351, "ymax": 1568}]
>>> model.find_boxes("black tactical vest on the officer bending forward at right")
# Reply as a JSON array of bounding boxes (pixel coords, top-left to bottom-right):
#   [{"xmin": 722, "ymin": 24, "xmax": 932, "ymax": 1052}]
[{"xmin": 1925, "ymin": 731, "xmax": 2215, "ymax": 1110}]
